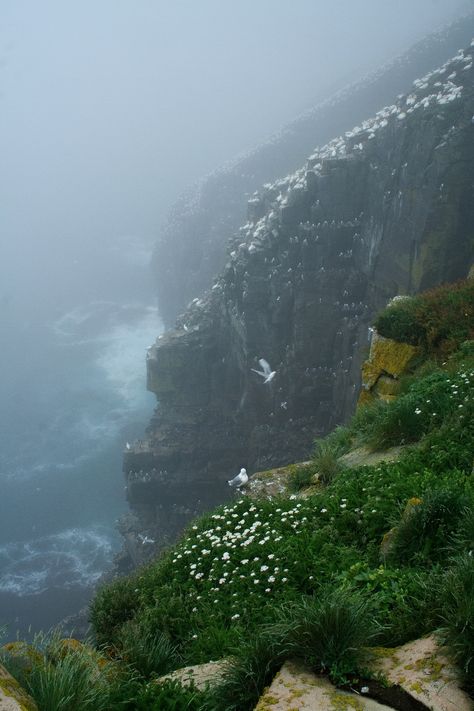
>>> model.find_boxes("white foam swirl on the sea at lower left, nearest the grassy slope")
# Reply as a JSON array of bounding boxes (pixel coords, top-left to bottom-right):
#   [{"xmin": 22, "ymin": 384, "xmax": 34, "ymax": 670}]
[{"xmin": 0, "ymin": 526, "xmax": 113, "ymax": 597}]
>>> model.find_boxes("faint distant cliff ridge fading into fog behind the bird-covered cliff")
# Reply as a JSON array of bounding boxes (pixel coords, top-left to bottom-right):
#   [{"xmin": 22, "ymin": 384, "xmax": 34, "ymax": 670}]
[{"xmin": 154, "ymin": 15, "xmax": 474, "ymax": 326}]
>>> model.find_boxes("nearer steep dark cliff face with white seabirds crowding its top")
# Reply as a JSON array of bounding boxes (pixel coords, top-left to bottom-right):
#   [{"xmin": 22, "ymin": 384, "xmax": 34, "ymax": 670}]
[{"xmin": 124, "ymin": 41, "xmax": 474, "ymax": 560}]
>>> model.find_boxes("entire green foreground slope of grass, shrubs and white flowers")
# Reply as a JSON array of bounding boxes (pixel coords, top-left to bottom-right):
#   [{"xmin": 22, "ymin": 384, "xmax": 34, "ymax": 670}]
[{"xmin": 6, "ymin": 283, "xmax": 474, "ymax": 711}]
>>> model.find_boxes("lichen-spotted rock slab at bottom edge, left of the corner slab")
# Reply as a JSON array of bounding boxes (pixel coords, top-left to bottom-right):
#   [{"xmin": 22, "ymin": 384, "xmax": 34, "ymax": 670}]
[{"xmin": 255, "ymin": 662, "xmax": 390, "ymax": 711}]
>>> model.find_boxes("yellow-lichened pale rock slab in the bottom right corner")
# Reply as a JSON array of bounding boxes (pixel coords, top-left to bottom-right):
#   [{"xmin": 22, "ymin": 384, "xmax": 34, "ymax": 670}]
[{"xmin": 371, "ymin": 636, "xmax": 474, "ymax": 711}]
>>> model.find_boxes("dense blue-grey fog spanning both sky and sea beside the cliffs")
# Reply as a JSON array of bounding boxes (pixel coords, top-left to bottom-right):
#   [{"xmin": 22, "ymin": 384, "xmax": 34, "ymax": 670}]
[{"xmin": 0, "ymin": 0, "xmax": 472, "ymax": 632}]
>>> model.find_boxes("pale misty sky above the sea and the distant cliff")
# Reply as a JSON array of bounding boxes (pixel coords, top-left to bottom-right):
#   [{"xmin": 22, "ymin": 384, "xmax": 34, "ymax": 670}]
[{"xmin": 0, "ymin": 0, "xmax": 469, "ymax": 308}]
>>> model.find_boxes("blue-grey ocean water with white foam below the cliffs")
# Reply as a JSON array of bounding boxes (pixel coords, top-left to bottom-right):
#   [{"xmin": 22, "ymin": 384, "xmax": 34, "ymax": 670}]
[{"xmin": 0, "ymin": 249, "xmax": 161, "ymax": 639}]
